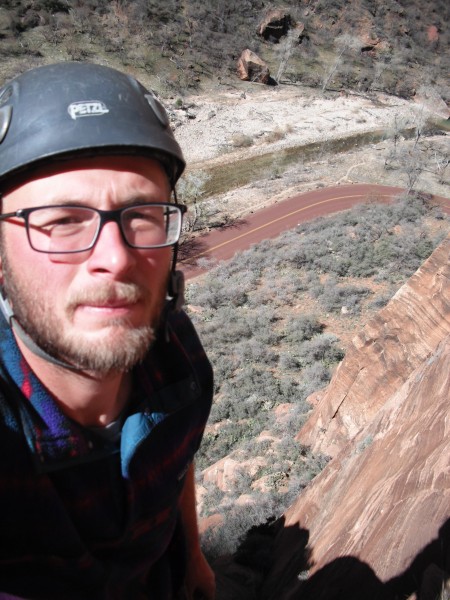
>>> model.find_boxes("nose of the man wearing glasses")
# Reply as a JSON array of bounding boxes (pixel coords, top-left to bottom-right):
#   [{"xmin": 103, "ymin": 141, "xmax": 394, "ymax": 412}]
[{"xmin": 88, "ymin": 221, "xmax": 136, "ymax": 277}]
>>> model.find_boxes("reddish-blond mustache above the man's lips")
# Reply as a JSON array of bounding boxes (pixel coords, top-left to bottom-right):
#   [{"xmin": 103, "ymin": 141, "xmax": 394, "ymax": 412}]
[{"xmin": 67, "ymin": 282, "xmax": 148, "ymax": 311}]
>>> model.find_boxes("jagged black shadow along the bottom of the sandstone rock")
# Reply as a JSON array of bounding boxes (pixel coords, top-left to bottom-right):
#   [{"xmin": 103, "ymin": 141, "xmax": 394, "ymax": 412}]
[{"xmin": 214, "ymin": 519, "xmax": 450, "ymax": 600}]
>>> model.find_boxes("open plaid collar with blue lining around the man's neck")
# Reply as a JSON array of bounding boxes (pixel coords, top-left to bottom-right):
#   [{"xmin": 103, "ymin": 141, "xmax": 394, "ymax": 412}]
[{"xmin": 0, "ymin": 317, "xmax": 200, "ymax": 472}]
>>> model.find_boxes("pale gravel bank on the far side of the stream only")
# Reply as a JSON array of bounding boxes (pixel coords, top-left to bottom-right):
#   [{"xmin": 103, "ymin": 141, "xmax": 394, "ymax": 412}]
[{"xmin": 176, "ymin": 86, "xmax": 414, "ymax": 166}]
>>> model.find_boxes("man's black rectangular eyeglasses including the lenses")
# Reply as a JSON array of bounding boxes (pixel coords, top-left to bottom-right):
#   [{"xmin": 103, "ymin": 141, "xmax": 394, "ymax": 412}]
[{"xmin": 0, "ymin": 203, "xmax": 187, "ymax": 254}]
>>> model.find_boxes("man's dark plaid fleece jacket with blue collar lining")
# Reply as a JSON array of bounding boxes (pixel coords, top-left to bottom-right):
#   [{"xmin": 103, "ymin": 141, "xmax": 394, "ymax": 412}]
[{"xmin": 0, "ymin": 313, "xmax": 213, "ymax": 600}]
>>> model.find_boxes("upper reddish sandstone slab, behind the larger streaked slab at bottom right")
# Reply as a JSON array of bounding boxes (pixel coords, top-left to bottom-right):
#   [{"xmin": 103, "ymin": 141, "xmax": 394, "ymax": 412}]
[{"xmin": 298, "ymin": 232, "xmax": 450, "ymax": 456}]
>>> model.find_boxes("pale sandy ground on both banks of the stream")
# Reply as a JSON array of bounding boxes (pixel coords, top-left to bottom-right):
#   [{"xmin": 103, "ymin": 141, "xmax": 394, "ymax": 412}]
[{"xmin": 172, "ymin": 84, "xmax": 450, "ymax": 214}]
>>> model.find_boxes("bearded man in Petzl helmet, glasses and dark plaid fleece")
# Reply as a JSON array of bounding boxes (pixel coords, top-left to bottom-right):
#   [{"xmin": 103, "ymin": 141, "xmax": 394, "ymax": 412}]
[{"xmin": 0, "ymin": 63, "xmax": 214, "ymax": 600}]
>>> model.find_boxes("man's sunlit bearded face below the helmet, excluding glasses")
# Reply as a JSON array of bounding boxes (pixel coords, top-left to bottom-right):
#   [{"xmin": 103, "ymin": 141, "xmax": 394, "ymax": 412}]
[{"xmin": 0, "ymin": 157, "xmax": 172, "ymax": 373}]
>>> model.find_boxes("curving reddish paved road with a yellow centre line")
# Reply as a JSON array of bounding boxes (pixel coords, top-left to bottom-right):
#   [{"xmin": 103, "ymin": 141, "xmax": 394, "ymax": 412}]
[{"xmin": 180, "ymin": 184, "xmax": 450, "ymax": 279}]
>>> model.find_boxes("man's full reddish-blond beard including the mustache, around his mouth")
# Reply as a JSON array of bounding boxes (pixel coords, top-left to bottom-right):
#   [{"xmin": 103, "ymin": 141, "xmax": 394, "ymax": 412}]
[{"xmin": 2, "ymin": 253, "xmax": 166, "ymax": 375}]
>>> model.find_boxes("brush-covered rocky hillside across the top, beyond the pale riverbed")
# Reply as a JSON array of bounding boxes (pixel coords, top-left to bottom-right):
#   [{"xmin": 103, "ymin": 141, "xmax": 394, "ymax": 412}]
[{"xmin": 0, "ymin": 0, "xmax": 450, "ymax": 100}]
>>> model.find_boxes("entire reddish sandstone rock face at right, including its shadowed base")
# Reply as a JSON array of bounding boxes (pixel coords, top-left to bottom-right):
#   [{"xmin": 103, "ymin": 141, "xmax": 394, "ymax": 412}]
[{"xmin": 259, "ymin": 237, "xmax": 450, "ymax": 600}]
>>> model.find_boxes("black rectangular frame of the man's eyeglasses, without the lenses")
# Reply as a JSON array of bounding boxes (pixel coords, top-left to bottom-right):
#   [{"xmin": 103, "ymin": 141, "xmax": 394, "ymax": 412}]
[{"xmin": 0, "ymin": 202, "xmax": 187, "ymax": 254}]
